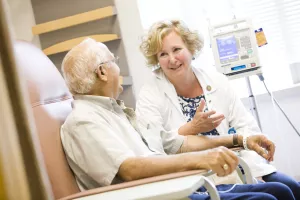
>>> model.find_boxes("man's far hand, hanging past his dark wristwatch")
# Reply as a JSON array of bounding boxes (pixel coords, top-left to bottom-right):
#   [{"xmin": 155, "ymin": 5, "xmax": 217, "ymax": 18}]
[{"xmin": 247, "ymin": 135, "xmax": 275, "ymax": 162}]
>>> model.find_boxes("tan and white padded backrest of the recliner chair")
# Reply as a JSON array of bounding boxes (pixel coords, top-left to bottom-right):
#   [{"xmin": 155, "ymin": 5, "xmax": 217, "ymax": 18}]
[{"xmin": 14, "ymin": 41, "xmax": 79, "ymax": 199}]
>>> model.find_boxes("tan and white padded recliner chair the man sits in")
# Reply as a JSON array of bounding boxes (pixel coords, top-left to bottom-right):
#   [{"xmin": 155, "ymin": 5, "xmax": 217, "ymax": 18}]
[{"xmin": 14, "ymin": 41, "xmax": 255, "ymax": 200}]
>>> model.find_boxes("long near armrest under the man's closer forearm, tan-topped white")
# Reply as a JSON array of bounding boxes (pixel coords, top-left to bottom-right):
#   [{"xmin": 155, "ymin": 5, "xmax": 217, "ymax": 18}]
[{"xmin": 60, "ymin": 170, "xmax": 214, "ymax": 200}]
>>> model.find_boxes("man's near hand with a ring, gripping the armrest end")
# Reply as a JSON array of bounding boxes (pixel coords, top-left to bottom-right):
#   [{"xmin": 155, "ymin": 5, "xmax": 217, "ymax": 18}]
[{"xmin": 202, "ymin": 147, "xmax": 239, "ymax": 176}]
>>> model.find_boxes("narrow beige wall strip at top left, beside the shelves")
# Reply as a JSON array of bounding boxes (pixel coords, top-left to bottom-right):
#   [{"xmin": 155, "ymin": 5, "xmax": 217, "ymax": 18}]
[{"xmin": 7, "ymin": 0, "xmax": 40, "ymax": 47}]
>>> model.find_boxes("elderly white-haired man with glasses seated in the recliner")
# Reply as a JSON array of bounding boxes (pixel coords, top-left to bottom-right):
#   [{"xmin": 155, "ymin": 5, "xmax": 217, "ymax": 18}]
[{"xmin": 61, "ymin": 39, "xmax": 294, "ymax": 199}]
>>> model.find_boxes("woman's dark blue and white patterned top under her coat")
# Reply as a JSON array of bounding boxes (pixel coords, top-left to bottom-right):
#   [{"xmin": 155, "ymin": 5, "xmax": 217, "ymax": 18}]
[{"xmin": 178, "ymin": 95, "xmax": 220, "ymax": 135}]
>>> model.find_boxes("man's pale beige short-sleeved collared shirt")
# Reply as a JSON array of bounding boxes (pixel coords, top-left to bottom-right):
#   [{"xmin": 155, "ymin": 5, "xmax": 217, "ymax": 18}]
[{"xmin": 61, "ymin": 95, "xmax": 183, "ymax": 190}]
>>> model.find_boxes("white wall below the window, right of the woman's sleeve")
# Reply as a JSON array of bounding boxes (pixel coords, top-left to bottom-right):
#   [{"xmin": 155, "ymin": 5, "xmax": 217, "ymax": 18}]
[{"xmin": 242, "ymin": 86, "xmax": 300, "ymax": 181}]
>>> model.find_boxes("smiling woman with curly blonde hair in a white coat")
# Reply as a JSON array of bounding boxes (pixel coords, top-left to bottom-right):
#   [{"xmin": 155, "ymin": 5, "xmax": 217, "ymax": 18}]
[{"xmin": 136, "ymin": 20, "xmax": 300, "ymax": 199}]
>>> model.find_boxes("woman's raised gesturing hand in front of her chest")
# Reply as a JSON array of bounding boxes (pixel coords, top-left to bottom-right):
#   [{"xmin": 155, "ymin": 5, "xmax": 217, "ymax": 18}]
[{"xmin": 190, "ymin": 99, "xmax": 225, "ymax": 133}]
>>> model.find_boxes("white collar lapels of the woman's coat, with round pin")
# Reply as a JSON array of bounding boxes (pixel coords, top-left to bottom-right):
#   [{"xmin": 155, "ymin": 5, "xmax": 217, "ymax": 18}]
[{"xmin": 153, "ymin": 67, "xmax": 217, "ymax": 116}]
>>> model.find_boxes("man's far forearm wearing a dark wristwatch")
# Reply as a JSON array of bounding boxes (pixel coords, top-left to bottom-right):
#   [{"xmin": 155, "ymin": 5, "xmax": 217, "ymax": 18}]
[{"xmin": 178, "ymin": 135, "xmax": 243, "ymax": 153}]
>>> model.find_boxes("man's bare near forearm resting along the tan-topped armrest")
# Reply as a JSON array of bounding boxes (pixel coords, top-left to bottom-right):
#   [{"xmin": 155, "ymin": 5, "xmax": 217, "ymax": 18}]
[{"xmin": 118, "ymin": 153, "xmax": 208, "ymax": 181}]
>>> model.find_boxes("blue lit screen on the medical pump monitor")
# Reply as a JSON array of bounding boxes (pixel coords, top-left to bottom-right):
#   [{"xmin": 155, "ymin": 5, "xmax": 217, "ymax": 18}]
[{"xmin": 217, "ymin": 36, "xmax": 239, "ymax": 63}]
